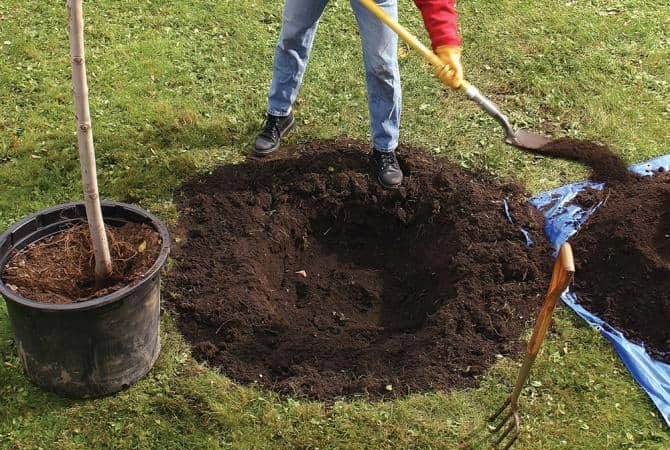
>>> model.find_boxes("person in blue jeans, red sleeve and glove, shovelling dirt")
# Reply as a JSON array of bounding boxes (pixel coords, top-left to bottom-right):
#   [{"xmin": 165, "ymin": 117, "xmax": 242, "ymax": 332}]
[{"xmin": 254, "ymin": 0, "xmax": 463, "ymax": 188}]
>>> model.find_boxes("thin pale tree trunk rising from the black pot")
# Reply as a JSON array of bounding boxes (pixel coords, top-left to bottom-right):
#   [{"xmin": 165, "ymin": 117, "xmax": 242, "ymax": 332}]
[{"xmin": 67, "ymin": 0, "xmax": 112, "ymax": 285}]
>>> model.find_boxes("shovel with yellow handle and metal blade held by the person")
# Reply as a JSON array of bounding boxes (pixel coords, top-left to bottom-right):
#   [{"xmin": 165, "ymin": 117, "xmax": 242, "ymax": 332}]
[{"xmin": 360, "ymin": 0, "xmax": 551, "ymax": 150}]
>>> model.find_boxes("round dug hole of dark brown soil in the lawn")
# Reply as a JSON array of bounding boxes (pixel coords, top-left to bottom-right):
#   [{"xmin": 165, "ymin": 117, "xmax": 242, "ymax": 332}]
[{"xmin": 166, "ymin": 140, "xmax": 552, "ymax": 399}]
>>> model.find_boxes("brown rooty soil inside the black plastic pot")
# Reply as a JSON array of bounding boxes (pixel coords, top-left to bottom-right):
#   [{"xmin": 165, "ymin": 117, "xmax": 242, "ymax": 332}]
[{"xmin": 2, "ymin": 223, "xmax": 161, "ymax": 304}]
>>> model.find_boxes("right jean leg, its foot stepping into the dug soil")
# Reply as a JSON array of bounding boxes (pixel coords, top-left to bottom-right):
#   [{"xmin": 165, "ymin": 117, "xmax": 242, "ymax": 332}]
[{"xmin": 351, "ymin": 0, "xmax": 402, "ymax": 151}]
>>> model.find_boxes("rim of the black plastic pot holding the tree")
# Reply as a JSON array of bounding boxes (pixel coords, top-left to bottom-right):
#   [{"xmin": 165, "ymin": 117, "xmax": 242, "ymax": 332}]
[{"xmin": 0, "ymin": 200, "xmax": 171, "ymax": 312}]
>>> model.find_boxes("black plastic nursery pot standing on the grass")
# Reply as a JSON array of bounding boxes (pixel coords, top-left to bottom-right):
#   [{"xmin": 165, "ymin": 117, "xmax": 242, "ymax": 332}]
[{"xmin": 0, "ymin": 202, "xmax": 170, "ymax": 398}]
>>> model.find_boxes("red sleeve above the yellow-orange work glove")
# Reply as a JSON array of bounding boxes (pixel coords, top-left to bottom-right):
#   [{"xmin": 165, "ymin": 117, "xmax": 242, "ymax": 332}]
[{"xmin": 414, "ymin": 0, "xmax": 461, "ymax": 49}]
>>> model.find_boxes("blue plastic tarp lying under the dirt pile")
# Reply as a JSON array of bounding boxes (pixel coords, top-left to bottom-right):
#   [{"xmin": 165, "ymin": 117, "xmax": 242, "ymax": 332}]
[{"xmin": 530, "ymin": 155, "xmax": 670, "ymax": 426}]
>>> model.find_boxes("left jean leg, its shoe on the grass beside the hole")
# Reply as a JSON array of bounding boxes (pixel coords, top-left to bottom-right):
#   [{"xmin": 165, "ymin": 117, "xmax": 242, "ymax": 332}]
[{"xmin": 268, "ymin": 0, "xmax": 328, "ymax": 117}]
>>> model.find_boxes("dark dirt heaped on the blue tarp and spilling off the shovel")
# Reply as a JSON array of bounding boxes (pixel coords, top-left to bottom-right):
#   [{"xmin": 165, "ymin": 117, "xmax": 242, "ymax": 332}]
[{"xmin": 540, "ymin": 140, "xmax": 670, "ymax": 363}]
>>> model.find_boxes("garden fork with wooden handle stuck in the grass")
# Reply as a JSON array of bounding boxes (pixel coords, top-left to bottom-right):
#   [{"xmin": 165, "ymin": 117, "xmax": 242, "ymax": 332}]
[{"xmin": 488, "ymin": 242, "xmax": 575, "ymax": 450}]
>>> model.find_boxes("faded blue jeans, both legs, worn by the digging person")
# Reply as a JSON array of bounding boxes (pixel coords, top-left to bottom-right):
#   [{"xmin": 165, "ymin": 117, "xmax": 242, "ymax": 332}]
[{"xmin": 268, "ymin": 0, "xmax": 401, "ymax": 151}]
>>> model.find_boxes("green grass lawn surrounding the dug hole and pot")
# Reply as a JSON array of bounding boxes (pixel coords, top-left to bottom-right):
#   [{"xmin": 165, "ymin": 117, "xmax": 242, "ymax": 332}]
[{"xmin": 0, "ymin": 0, "xmax": 670, "ymax": 449}]
